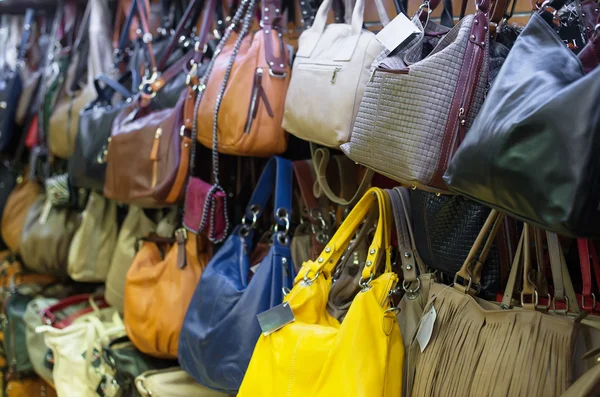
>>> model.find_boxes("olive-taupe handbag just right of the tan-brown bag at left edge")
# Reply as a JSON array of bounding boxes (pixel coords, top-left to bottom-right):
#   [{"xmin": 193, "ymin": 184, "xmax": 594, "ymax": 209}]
[{"xmin": 20, "ymin": 195, "xmax": 80, "ymax": 279}]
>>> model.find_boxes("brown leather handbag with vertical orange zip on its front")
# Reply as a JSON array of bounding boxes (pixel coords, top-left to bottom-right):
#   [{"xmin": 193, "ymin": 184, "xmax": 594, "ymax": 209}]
[{"xmin": 104, "ymin": 92, "xmax": 191, "ymax": 208}]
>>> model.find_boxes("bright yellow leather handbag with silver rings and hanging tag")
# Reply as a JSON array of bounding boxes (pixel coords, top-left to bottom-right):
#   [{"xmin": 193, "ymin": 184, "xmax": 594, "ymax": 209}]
[{"xmin": 238, "ymin": 188, "xmax": 404, "ymax": 397}]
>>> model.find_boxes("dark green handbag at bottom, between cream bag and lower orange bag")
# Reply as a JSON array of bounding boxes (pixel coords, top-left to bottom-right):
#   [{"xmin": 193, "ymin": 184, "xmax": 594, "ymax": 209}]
[{"xmin": 103, "ymin": 336, "xmax": 177, "ymax": 397}]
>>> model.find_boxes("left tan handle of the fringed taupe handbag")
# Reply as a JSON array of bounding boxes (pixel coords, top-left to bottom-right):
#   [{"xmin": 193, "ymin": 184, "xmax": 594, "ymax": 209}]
[{"xmin": 454, "ymin": 209, "xmax": 504, "ymax": 294}]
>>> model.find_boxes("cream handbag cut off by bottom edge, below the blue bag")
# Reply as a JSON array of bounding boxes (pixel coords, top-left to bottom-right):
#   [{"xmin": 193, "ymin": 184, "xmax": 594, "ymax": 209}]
[{"xmin": 135, "ymin": 367, "xmax": 227, "ymax": 397}]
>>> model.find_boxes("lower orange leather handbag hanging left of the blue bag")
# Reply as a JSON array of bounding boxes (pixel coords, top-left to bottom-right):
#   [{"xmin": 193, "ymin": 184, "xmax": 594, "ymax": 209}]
[{"xmin": 124, "ymin": 229, "xmax": 210, "ymax": 358}]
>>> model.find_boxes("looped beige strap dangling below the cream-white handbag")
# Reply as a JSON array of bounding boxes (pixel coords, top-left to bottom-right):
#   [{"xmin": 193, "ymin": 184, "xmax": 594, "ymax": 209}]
[{"xmin": 310, "ymin": 143, "xmax": 374, "ymax": 206}]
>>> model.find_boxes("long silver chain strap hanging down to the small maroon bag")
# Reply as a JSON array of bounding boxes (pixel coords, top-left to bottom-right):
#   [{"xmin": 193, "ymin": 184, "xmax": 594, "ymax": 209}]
[{"xmin": 184, "ymin": 0, "xmax": 256, "ymax": 244}]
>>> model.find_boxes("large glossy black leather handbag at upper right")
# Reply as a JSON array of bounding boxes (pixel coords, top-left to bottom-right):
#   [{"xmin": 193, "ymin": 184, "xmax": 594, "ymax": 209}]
[{"xmin": 444, "ymin": 6, "xmax": 600, "ymax": 238}]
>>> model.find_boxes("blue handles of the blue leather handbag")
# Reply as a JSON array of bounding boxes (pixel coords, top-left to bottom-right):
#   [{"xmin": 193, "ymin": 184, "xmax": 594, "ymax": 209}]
[{"xmin": 245, "ymin": 156, "xmax": 293, "ymax": 229}]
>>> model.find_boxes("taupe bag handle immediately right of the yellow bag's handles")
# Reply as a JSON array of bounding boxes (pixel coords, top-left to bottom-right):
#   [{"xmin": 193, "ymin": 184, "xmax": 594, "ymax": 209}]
[{"xmin": 386, "ymin": 187, "xmax": 426, "ymax": 282}]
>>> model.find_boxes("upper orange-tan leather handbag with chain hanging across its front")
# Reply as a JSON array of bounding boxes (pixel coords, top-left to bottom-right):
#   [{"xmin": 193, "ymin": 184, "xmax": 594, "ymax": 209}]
[{"xmin": 184, "ymin": 0, "xmax": 290, "ymax": 157}]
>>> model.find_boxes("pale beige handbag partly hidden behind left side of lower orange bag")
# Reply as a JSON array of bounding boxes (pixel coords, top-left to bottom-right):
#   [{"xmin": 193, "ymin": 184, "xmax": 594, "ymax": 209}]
[{"xmin": 104, "ymin": 206, "xmax": 177, "ymax": 313}]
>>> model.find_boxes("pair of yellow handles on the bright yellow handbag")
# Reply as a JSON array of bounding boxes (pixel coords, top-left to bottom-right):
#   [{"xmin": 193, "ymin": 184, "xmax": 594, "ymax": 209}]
[{"xmin": 295, "ymin": 188, "xmax": 391, "ymax": 287}]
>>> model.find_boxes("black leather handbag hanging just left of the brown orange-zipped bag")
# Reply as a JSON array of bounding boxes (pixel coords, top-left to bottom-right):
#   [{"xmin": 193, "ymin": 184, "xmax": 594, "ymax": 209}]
[{"xmin": 69, "ymin": 72, "xmax": 139, "ymax": 191}]
